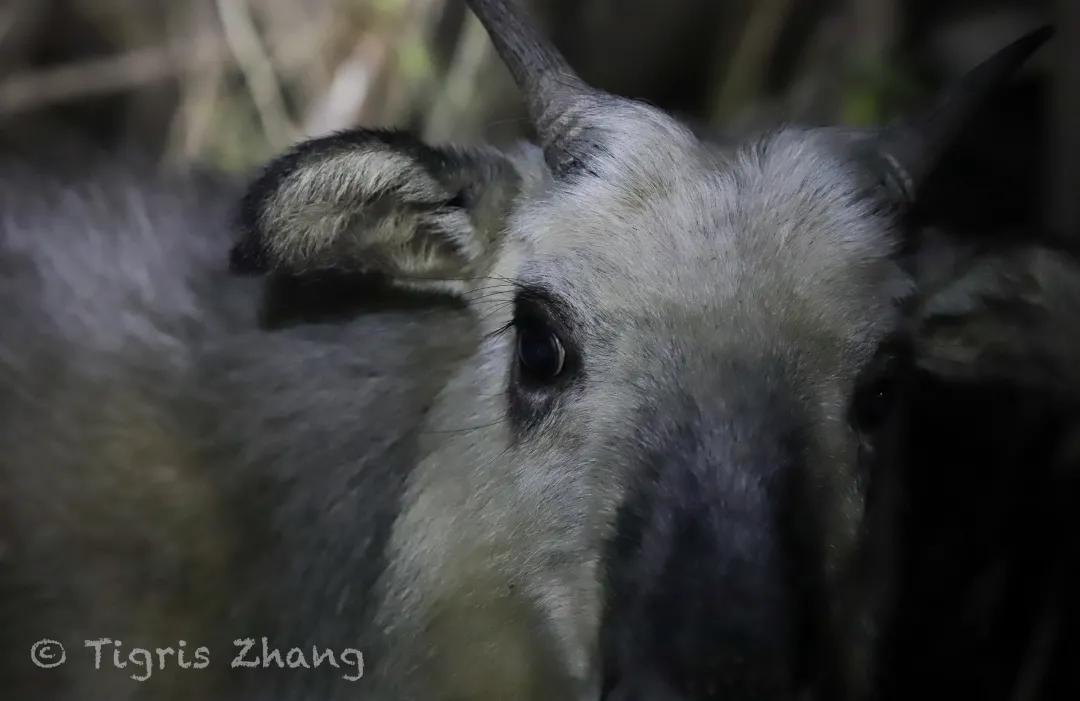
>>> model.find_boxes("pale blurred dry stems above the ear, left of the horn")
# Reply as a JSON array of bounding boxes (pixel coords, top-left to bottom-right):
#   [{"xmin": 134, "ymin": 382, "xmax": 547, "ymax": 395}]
[{"xmin": 0, "ymin": 0, "xmax": 445, "ymax": 170}]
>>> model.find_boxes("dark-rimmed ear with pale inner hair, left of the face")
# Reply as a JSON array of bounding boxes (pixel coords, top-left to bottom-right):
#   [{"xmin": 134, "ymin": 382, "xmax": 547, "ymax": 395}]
[{"xmin": 230, "ymin": 130, "xmax": 533, "ymax": 289}]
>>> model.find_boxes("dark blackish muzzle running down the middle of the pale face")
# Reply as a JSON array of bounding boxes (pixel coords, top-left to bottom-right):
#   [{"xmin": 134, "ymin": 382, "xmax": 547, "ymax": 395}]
[{"xmin": 603, "ymin": 388, "xmax": 800, "ymax": 701}]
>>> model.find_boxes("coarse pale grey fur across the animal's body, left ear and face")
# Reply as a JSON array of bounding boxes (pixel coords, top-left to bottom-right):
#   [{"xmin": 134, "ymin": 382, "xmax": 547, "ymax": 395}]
[{"xmin": 0, "ymin": 9, "xmax": 1062, "ymax": 701}]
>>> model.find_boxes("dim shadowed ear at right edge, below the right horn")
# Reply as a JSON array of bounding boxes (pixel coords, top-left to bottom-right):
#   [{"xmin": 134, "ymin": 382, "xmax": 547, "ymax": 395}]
[{"xmin": 916, "ymin": 235, "xmax": 1080, "ymax": 397}]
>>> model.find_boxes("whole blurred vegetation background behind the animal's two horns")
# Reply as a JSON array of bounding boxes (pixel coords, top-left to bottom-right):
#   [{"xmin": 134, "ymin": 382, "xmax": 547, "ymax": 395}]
[{"xmin": 0, "ymin": 0, "xmax": 1080, "ymax": 237}]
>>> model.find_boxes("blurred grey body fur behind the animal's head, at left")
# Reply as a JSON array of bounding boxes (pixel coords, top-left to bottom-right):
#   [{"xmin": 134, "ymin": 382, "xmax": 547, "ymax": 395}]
[{"xmin": 0, "ymin": 155, "xmax": 472, "ymax": 699}]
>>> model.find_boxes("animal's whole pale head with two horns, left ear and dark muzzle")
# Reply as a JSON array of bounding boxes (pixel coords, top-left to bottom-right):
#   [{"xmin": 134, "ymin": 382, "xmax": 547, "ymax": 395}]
[{"xmin": 233, "ymin": 0, "xmax": 1047, "ymax": 701}]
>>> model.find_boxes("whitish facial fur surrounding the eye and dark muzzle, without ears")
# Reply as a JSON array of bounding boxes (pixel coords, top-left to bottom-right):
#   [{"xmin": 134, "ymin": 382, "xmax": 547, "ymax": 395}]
[{"xmin": 369, "ymin": 103, "xmax": 912, "ymax": 699}]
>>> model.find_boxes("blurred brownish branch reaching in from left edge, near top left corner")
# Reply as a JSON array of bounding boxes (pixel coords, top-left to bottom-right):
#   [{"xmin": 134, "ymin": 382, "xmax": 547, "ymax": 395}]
[{"xmin": 0, "ymin": 38, "xmax": 228, "ymax": 116}]
